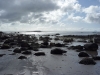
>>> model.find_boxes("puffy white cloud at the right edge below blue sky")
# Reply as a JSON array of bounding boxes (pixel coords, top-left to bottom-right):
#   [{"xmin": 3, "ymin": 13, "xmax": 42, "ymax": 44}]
[{"xmin": 83, "ymin": 5, "xmax": 100, "ymax": 23}]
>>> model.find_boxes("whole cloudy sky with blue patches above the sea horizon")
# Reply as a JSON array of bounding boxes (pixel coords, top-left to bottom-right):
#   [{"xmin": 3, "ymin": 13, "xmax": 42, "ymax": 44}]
[{"xmin": 0, "ymin": 0, "xmax": 100, "ymax": 31}]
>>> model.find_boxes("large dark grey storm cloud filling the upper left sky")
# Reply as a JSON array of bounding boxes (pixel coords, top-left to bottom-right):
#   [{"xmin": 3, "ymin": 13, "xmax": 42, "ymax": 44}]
[{"xmin": 0, "ymin": 0, "xmax": 59, "ymax": 22}]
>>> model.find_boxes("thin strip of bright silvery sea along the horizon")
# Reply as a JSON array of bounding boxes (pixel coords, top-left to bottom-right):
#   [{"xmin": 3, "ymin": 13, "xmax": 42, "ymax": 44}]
[{"xmin": 20, "ymin": 31, "xmax": 100, "ymax": 35}]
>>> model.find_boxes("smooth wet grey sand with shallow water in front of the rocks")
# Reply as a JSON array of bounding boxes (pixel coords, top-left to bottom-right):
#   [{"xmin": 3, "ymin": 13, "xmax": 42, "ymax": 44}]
[{"xmin": 0, "ymin": 42, "xmax": 100, "ymax": 75}]
